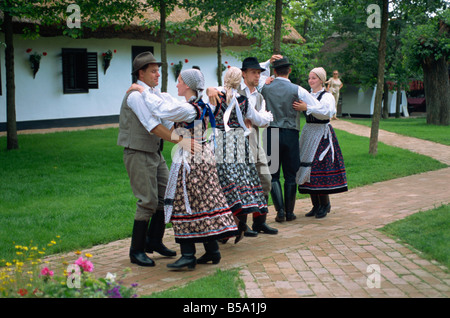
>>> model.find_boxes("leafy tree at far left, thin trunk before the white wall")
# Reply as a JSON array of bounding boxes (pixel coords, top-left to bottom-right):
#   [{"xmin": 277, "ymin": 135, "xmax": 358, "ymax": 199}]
[{"xmin": 0, "ymin": 0, "xmax": 139, "ymax": 150}]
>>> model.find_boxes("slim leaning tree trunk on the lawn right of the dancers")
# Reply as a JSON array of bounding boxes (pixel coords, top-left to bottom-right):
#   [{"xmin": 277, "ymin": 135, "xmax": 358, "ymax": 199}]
[{"xmin": 369, "ymin": 0, "xmax": 389, "ymax": 155}]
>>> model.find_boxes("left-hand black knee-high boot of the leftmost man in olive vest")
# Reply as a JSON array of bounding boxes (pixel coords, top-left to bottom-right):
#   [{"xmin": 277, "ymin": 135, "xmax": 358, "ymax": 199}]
[{"xmin": 130, "ymin": 220, "xmax": 155, "ymax": 266}]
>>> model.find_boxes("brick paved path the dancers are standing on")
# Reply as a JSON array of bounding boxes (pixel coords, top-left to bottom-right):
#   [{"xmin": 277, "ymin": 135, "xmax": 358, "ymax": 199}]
[{"xmin": 44, "ymin": 120, "xmax": 450, "ymax": 298}]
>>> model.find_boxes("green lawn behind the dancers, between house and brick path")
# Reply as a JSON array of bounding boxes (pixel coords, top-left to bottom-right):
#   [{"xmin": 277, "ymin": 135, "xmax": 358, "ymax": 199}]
[{"xmin": 0, "ymin": 128, "xmax": 445, "ymax": 259}]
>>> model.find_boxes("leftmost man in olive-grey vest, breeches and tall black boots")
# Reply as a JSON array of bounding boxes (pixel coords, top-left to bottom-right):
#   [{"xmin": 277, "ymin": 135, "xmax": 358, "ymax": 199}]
[{"xmin": 117, "ymin": 52, "xmax": 178, "ymax": 266}]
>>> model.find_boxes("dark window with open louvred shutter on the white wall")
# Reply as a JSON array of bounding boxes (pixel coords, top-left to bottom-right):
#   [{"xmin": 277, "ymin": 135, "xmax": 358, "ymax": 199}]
[{"xmin": 62, "ymin": 49, "xmax": 98, "ymax": 94}]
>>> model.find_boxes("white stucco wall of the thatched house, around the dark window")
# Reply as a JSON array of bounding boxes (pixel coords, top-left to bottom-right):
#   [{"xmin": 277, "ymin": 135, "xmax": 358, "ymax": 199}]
[{"xmin": 0, "ymin": 34, "xmax": 245, "ymax": 123}]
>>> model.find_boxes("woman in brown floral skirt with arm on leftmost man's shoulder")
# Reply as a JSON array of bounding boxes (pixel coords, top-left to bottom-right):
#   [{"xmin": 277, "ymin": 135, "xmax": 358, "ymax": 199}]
[{"xmin": 128, "ymin": 69, "xmax": 237, "ymax": 270}]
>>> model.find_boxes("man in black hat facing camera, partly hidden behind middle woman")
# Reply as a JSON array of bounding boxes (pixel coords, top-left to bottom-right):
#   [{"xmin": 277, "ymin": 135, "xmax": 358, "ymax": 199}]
[{"xmin": 238, "ymin": 57, "xmax": 278, "ymax": 236}]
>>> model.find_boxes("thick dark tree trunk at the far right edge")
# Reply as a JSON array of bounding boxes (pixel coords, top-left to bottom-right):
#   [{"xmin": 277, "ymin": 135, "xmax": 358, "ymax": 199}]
[{"xmin": 422, "ymin": 57, "xmax": 450, "ymax": 126}]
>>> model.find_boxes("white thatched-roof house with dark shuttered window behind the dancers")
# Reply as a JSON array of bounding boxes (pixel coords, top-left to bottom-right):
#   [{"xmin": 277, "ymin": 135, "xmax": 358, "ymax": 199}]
[{"xmin": 0, "ymin": 8, "xmax": 301, "ymax": 131}]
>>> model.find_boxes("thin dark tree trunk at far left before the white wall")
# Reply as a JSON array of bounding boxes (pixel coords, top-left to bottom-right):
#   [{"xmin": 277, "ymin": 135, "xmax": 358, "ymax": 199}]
[{"xmin": 3, "ymin": 12, "xmax": 19, "ymax": 150}]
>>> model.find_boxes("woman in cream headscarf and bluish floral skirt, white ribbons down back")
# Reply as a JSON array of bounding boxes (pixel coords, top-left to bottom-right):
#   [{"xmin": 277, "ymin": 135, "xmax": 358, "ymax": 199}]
[{"xmin": 214, "ymin": 67, "xmax": 273, "ymax": 243}]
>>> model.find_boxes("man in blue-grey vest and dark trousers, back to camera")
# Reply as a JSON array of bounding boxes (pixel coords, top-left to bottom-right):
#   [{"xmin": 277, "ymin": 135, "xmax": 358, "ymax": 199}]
[{"xmin": 261, "ymin": 57, "xmax": 319, "ymax": 222}]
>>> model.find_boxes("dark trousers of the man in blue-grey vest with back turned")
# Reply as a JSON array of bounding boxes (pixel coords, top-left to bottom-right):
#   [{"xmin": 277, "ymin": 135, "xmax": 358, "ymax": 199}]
[{"xmin": 264, "ymin": 127, "xmax": 300, "ymax": 184}]
